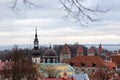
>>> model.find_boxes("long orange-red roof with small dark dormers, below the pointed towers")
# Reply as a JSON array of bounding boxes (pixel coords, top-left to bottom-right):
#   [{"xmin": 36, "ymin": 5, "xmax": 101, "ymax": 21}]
[{"xmin": 71, "ymin": 56, "xmax": 105, "ymax": 67}]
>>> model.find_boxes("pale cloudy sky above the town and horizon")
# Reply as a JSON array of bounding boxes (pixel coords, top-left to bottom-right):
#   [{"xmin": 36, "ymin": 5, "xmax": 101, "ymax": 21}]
[{"xmin": 0, "ymin": 0, "xmax": 120, "ymax": 45}]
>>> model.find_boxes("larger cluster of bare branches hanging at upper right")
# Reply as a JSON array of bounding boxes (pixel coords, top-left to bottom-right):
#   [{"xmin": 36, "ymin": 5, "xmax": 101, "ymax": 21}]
[{"xmin": 59, "ymin": 0, "xmax": 109, "ymax": 25}]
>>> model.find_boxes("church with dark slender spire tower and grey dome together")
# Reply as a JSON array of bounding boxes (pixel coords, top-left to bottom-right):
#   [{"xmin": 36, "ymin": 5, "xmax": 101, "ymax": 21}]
[{"xmin": 32, "ymin": 29, "xmax": 59, "ymax": 64}]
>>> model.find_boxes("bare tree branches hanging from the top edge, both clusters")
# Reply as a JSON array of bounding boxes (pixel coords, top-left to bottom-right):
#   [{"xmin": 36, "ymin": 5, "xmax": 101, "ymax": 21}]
[{"xmin": 11, "ymin": 0, "xmax": 110, "ymax": 25}]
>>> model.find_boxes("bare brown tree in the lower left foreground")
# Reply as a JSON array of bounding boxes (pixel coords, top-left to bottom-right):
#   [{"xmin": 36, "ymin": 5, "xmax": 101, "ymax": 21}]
[{"xmin": 2, "ymin": 47, "xmax": 37, "ymax": 80}]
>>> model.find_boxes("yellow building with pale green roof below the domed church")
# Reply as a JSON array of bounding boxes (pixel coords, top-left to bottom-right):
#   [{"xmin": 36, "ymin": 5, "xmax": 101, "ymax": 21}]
[{"xmin": 40, "ymin": 63, "xmax": 75, "ymax": 78}]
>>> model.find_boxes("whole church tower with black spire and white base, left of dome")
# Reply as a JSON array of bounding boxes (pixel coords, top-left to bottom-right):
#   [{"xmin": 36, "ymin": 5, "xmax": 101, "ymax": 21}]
[{"xmin": 32, "ymin": 28, "xmax": 40, "ymax": 64}]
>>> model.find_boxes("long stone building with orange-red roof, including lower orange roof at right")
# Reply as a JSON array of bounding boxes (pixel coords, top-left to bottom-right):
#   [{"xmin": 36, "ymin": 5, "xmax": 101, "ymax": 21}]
[{"xmin": 70, "ymin": 56, "xmax": 115, "ymax": 73}]
